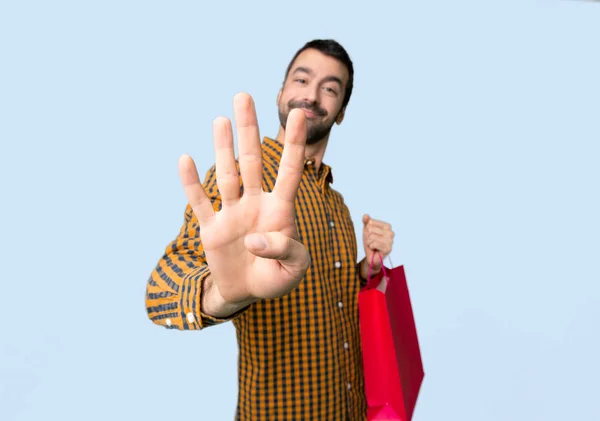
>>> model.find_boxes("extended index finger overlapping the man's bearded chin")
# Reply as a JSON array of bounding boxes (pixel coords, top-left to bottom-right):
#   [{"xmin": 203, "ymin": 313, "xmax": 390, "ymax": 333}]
[{"xmin": 273, "ymin": 108, "xmax": 306, "ymax": 202}]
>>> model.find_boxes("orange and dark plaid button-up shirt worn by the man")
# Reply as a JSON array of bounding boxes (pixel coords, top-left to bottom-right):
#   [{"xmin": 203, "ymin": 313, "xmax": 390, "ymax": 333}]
[{"xmin": 146, "ymin": 138, "xmax": 366, "ymax": 421}]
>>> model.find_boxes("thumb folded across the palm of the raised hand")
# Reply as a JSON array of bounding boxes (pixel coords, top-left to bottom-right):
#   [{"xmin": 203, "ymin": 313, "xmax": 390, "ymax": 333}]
[{"xmin": 245, "ymin": 232, "xmax": 310, "ymax": 272}]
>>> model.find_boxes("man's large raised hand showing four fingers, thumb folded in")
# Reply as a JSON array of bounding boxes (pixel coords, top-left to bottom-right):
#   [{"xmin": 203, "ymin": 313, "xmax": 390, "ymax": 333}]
[{"xmin": 179, "ymin": 94, "xmax": 310, "ymax": 304}]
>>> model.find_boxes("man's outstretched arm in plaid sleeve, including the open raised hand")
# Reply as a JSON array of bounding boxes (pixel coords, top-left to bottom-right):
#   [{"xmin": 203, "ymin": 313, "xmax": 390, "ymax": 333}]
[{"xmin": 146, "ymin": 94, "xmax": 310, "ymax": 330}]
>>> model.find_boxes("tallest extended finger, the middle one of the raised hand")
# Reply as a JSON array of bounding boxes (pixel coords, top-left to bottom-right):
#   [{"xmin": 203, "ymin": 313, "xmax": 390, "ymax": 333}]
[{"xmin": 233, "ymin": 93, "xmax": 262, "ymax": 195}]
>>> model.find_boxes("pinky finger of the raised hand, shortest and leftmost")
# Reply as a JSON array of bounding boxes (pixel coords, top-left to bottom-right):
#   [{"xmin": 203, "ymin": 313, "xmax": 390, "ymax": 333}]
[{"xmin": 179, "ymin": 155, "xmax": 215, "ymax": 225}]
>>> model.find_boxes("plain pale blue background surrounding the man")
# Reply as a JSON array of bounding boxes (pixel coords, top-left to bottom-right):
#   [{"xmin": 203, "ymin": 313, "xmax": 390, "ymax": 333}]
[{"xmin": 0, "ymin": 0, "xmax": 600, "ymax": 421}]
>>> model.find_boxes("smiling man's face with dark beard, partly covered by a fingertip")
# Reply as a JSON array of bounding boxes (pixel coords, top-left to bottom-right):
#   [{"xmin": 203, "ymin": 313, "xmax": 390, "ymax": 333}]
[{"xmin": 277, "ymin": 49, "xmax": 349, "ymax": 145}]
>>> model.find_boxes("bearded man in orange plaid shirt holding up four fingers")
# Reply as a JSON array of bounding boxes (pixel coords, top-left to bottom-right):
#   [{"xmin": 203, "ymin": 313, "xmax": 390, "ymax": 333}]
[{"xmin": 146, "ymin": 40, "xmax": 394, "ymax": 421}]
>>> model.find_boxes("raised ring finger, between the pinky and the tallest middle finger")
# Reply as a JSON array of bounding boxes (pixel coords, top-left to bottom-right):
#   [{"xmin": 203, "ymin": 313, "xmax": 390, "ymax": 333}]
[{"xmin": 213, "ymin": 117, "xmax": 240, "ymax": 206}]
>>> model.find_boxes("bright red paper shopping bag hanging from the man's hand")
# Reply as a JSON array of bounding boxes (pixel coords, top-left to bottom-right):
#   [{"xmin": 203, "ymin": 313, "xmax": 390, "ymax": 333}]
[{"xmin": 358, "ymin": 256, "xmax": 424, "ymax": 421}]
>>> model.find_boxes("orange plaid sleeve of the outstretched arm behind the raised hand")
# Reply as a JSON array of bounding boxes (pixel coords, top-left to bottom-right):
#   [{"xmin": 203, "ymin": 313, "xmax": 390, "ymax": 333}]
[{"xmin": 146, "ymin": 162, "xmax": 242, "ymax": 330}]
